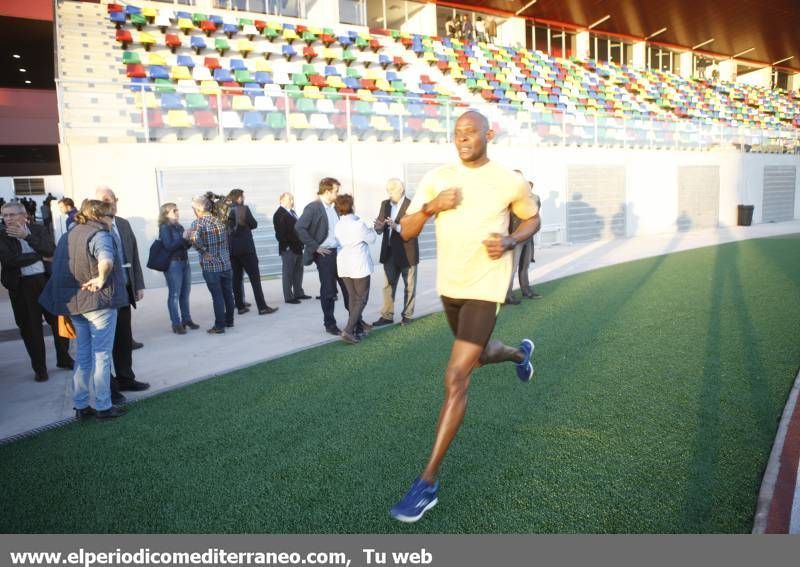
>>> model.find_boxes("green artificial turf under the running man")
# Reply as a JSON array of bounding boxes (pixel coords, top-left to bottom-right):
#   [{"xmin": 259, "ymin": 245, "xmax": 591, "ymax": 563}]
[{"xmin": 0, "ymin": 236, "xmax": 800, "ymax": 533}]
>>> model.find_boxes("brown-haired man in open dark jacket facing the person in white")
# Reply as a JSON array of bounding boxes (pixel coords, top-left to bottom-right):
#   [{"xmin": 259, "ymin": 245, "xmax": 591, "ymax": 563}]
[{"xmin": 294, "ymin": 177, "xmax": 349, "ymax": 335}]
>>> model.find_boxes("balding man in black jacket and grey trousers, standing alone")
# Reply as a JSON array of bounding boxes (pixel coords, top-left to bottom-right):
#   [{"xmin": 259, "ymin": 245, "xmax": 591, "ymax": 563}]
[{"xmin": 272, "ymin": 193, "xmax": 311, "ymax": 304}]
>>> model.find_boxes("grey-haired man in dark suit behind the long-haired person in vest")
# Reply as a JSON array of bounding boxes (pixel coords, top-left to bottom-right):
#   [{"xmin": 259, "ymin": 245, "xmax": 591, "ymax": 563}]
[{"xmin": 95, "ymin": 187, "xmax": 150, "ymax": 404}]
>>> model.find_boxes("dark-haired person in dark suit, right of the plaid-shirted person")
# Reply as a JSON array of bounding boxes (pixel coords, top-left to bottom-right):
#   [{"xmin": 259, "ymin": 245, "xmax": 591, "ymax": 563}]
[{"xmin": 227, "ymin": 189, "xmax": 278, "ymax": 315}]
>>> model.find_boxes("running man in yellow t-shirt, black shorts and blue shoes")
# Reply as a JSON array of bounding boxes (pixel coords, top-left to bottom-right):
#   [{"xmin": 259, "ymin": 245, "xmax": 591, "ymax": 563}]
[{"xmin": 389, "ymin": 111, "xmax": 540, "ymax": 522}]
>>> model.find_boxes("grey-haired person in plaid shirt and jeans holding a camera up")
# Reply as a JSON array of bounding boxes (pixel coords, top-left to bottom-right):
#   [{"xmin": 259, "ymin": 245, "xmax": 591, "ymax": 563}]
[{"xmin": 185, "ymin": 195, "xmax": 234, "ymax": 335}]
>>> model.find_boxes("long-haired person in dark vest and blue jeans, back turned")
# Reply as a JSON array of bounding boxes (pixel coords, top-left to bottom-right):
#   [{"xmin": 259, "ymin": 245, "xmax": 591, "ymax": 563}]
[{"xmin": 39, "ymin": 199, "xmax": 128, "ymax": 419}]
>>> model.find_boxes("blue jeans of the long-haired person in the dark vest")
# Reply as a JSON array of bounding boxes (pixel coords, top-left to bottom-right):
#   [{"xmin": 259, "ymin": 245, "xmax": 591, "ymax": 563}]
[{"xmin": 71, "ymin": 309, "xmax": 117, "ymax": 411}]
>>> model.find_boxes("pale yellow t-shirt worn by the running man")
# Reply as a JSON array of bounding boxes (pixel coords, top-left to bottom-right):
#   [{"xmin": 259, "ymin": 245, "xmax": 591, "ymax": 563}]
[{"xmin": 406, "ymin": 161, "xmax": 539, "ymax": 303}]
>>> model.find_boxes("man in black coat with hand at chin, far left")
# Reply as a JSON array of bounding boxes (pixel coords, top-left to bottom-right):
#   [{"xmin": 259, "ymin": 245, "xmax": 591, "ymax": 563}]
[{"xmin": 0, "ymin": 203, "xmax": 74, "ymax": 382}]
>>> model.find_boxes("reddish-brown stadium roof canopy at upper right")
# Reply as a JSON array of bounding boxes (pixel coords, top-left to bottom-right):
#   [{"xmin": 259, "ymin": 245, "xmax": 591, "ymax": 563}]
[{"xmin": 446, "ymin": 0, "xmax": 800, "ymax": 70}]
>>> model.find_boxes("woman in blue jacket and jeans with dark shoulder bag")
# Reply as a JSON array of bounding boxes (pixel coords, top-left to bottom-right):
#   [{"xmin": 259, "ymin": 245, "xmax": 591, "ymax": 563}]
[{"xmin": 158, "ymin": 203, "xmax": 200, "ymax": 335}]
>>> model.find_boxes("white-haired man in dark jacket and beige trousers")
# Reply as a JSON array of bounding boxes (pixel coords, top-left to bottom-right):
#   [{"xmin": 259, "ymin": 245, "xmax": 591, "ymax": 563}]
[{"xmin": 372, "ymin": 178, "xmax": 419, "ymax": 327}]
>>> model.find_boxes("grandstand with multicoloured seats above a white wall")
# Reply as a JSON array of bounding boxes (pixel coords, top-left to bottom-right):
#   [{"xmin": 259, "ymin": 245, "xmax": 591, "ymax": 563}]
[{"xmin": 32, "ymin": 0, "xmax": 800, "ymax": 285}]
